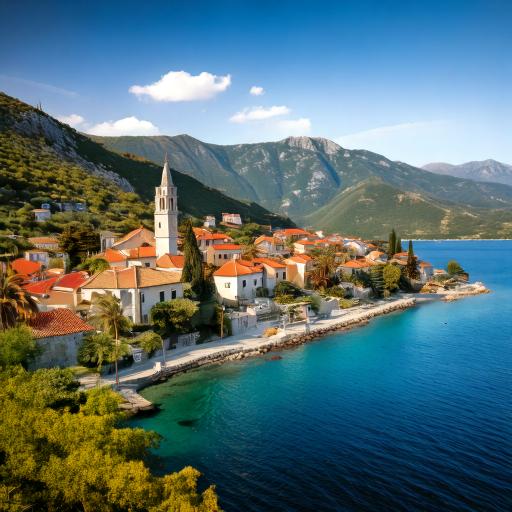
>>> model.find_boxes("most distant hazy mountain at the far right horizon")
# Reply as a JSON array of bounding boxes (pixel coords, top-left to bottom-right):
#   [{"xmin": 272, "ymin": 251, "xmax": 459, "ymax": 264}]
[{"xmin": 422, "ymin": 160, "xmax": 512, "ymax": 186}]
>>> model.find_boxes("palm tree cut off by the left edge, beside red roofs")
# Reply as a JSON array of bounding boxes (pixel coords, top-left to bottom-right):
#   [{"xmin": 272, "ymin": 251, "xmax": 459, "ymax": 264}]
[{"xmin": 0, "ymin": 263, "xmax": 37, "ymax": 331}]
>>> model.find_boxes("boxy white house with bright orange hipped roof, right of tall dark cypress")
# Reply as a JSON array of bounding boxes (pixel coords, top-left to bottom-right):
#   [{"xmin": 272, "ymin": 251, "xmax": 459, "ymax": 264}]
[{"xmin": 213, "ymin": 260, "xmax": 263, "ymax": 304}]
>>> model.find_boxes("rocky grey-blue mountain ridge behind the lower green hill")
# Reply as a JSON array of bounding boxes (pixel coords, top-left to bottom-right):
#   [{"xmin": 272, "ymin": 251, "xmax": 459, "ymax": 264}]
[{"xmin": 94, "ymin": 135, "xmax": 512, "ymax": 216}]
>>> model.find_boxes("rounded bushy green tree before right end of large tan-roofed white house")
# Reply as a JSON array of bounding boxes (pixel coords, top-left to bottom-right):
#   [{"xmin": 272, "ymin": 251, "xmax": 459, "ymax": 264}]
[{"xmin": 151, "ymin": 299, "xmax": 199, "ymax": 334}]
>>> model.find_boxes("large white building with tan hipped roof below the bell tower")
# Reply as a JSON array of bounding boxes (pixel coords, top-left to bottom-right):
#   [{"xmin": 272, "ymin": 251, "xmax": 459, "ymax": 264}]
[{"xmin": 80, "ymin": 266, "xmax": 183, "ymax": 323}]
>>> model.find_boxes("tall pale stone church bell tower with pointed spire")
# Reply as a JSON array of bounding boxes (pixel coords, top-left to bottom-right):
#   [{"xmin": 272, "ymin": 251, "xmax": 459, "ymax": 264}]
[{"xmin": 155, "ymin": 154, "xmax": 178, "ymax": 258}]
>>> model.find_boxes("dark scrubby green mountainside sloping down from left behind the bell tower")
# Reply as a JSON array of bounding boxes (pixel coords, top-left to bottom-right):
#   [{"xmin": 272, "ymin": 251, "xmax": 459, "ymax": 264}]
[{"xmin": 0, "ymin": 93, "xmax": 293, "ymax": 234}]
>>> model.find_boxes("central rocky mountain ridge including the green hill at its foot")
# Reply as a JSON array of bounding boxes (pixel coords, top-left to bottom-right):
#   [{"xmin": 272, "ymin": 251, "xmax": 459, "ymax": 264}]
[{"xmin": 93, "ymin": 135, "xmax": 512, "ymax": 238}]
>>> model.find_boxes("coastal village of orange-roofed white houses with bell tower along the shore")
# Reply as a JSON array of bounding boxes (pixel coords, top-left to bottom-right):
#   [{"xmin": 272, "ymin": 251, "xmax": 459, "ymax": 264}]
[{"xmin": 2, "ymin": 159, "xmax": 482, "ymax": 394}]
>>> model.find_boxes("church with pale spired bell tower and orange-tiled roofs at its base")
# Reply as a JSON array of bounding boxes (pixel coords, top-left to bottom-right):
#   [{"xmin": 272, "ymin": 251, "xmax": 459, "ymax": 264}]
[{"xmin": 101, "ymin": 155, "xmax": 183, "ymax": 271}]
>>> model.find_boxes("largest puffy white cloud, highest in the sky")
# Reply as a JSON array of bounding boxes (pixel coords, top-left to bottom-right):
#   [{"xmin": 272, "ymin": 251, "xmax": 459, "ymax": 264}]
[{"xmin": 129, "ymin": 71, "xmax": 231, "ymax": 102}]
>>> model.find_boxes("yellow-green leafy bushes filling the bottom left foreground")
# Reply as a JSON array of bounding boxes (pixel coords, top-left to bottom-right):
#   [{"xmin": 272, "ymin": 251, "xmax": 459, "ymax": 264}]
[{"xmin": 0, "ymin": 367, "xmax": 220, "ymax": 512}]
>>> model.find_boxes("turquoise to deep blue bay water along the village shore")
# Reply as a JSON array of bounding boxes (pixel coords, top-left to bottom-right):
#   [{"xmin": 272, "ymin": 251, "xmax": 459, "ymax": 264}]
[{"xmin": 134, "ymin": 241, "xmax": 512, "ymax": 511}]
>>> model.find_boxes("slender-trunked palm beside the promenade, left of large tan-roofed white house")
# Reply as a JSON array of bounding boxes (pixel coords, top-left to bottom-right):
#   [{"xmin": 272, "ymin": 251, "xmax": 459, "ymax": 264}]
[{"xmin": 90, "ymin": 293, "xmax": 130, "ymax": 386}]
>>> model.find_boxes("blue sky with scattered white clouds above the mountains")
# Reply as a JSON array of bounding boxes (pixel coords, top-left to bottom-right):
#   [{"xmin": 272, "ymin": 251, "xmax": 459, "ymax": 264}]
[{"xmin": 0, "ymin": 0, "xmax": 512, "ymax": 165}]
